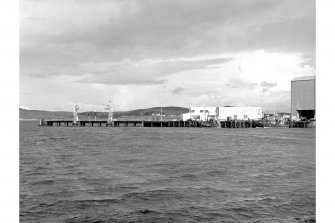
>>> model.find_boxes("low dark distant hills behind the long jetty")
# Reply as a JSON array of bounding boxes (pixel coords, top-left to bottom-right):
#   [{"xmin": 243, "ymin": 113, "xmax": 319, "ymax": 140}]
[{"xmin": 20, "ymin": 106, "xmax": 188, "ymax": 120}]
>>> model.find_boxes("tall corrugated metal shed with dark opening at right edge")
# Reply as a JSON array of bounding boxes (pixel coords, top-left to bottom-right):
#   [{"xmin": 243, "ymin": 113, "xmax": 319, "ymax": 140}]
[{"xmin": 291, "ymin": 76, "xmax": 315, "ymax": 119}]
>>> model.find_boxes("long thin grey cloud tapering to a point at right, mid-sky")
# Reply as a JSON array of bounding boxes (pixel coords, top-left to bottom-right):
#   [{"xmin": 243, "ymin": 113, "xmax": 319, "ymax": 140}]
[{"xmin": 25, "ymin": 58, "xmax": 233, "ymax": 85}]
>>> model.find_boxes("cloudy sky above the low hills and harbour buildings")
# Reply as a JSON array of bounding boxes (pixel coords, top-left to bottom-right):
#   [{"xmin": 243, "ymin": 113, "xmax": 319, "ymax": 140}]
[{"xmin": 19, "ymin": 0, "xmax": 315, "ymax": 112}]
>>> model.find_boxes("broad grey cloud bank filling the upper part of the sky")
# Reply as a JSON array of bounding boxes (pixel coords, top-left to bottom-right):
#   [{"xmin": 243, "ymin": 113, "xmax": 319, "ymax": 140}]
[{"xmin": 20, "ymin": 0, "xmax": 315, "ymax": 75}]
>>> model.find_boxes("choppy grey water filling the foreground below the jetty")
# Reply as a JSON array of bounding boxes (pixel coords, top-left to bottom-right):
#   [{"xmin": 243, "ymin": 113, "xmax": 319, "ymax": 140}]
[{"xmin": 20, "ymin": 122, "xmax": 315, "ymax": 223}]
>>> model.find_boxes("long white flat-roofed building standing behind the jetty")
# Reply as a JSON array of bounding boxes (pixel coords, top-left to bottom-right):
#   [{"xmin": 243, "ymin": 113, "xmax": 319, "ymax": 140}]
[{"xmin": 183, "ymin": 107, "xmax": 263, "ymax": 121}]
